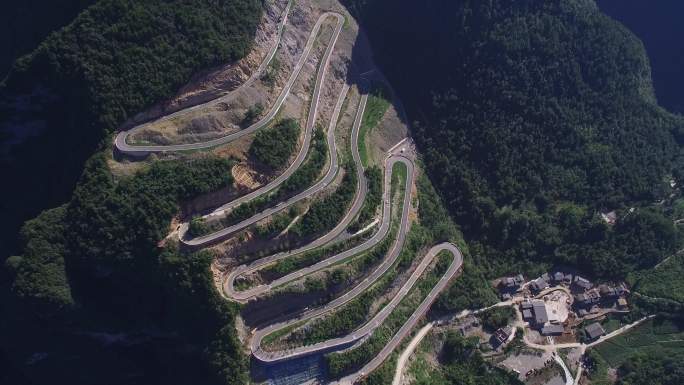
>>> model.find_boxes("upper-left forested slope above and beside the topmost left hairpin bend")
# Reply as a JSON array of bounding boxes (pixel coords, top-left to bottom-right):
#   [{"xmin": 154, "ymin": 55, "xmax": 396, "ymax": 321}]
[{"xmin": 0, "ymin": 0, "xmax": 261, "ymax": 254}]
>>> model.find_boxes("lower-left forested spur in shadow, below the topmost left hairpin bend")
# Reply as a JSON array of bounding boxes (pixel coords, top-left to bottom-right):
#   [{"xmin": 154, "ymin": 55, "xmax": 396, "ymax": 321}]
[{"xmin": 0, "ymin": 153, "xmax": 246, "ymax": 384}]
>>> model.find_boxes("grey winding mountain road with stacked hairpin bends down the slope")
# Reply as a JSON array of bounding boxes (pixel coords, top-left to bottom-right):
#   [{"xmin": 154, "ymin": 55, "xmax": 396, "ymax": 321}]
[{"xmin": 114, "ymin": 1, "xmax": 470, "ymax": 384}]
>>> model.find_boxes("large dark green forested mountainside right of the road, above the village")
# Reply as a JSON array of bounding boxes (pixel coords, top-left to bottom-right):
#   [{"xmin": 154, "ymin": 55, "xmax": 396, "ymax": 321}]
[{"xmin": 346, "ymin": 0, "xmax": 684, "ymax": 278}]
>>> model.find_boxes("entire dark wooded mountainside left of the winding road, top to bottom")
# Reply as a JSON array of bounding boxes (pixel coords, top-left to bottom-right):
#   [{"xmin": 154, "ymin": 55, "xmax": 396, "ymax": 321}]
[{"xmin": 0, "ymin": 0, "xmax": 261, "ymax": 384}]
